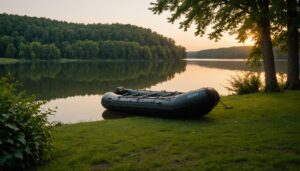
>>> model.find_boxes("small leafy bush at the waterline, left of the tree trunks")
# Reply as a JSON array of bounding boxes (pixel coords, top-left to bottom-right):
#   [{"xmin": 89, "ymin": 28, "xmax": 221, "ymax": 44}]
[{"xmin": 226, "ymin": 71, "xmax": 262, "ymax": 94}]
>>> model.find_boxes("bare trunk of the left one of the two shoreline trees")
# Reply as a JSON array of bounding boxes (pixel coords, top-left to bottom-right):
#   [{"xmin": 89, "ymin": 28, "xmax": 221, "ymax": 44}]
[{"xmin": 258, "ymin": 0, "xmax": 279, "ymax": 92}]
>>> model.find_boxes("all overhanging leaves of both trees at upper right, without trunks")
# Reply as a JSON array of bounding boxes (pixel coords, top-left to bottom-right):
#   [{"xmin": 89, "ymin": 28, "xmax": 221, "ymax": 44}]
[{"xmin": 150, "ymin": 0, "xmax": 285, "ymax": 66}]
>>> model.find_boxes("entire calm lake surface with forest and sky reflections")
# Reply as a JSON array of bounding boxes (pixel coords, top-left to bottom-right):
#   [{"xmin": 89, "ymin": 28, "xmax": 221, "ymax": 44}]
[{"xmin": 0, "ymin": 60, "xmax": 286, "ymax": 123}]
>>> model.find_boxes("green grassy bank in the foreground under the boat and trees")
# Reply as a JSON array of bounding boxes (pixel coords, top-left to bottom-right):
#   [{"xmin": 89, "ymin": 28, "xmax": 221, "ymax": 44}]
[{"xmin": 38, "ymin": 91, "xmax": 300, "ymax": 170}]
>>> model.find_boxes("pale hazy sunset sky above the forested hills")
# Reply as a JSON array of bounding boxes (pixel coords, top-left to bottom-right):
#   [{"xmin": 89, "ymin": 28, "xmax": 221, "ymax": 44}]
[{"xmin": 0, "ymin": 0, "xmax": 251, "ymax": 51}]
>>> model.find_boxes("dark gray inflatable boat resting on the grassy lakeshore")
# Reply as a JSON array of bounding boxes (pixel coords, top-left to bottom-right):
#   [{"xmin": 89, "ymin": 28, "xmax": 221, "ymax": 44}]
[{"xmin": 101, "ymin": 87, "xmax": 220, "ymax": 117}]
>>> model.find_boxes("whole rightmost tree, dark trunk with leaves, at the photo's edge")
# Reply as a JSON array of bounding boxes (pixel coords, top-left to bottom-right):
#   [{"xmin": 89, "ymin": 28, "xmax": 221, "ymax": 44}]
[{"xmin": 272, "ymin": 0, "xmax": 300, "ymax": 89}]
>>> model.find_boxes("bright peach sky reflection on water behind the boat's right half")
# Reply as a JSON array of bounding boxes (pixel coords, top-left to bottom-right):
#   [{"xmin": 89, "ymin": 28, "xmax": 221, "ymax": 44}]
[{"xmin": 150, "ymin": 61, "xmax": 287, "ymax": 95}]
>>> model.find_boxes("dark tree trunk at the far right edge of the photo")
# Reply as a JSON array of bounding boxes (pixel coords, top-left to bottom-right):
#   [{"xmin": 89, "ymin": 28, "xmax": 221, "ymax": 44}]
[{"xmin": 285, "ymin": 0, "xmax": 300, "ymax": 89}]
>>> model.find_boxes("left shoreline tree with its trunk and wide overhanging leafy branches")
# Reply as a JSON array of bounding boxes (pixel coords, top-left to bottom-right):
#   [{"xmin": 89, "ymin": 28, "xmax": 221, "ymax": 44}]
[{"xmin": 150, "ymin": 0, "xmax": 279, "ymax": 92}]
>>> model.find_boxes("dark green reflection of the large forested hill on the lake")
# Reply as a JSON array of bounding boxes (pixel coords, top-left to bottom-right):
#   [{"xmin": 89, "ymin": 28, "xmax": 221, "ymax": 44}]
[{"xmin": 0, "ymin": 61, "xmax": 186, "ymax": 100}]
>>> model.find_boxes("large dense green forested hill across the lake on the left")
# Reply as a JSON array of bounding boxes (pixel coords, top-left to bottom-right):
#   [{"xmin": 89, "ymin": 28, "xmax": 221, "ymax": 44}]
[{"xmin": 0, "ymin": 14, "xmax": 186, "ymax": 59}]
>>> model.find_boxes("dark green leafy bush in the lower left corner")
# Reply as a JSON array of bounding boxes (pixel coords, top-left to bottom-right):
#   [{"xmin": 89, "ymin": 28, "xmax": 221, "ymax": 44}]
[{"xmin": 0, "ymin": 77, "xmax": 52, "ymax": 169}]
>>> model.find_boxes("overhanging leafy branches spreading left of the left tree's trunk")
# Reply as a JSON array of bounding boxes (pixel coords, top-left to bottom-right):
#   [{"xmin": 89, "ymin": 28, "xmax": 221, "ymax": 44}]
[{"xmin": 151, "ymin": 0, "xmax": 261, "ymax": 42}]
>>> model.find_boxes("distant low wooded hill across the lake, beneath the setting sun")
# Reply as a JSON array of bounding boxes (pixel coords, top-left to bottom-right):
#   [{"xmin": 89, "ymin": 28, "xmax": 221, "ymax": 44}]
[{"xmin": 187, "ymin": 46, "xmax": 287, "ymax": 59}]
